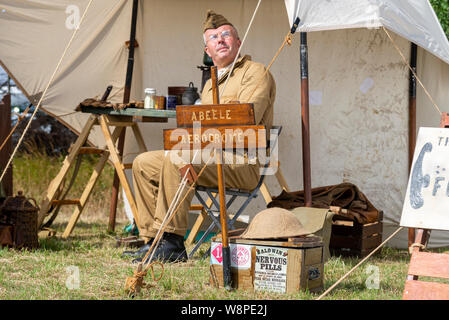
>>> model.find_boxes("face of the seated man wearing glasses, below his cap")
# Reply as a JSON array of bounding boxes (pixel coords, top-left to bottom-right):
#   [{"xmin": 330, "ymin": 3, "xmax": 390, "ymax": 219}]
[{"xmin": 204, "ymin": 25, "xmax": 241, "ymax": 68}]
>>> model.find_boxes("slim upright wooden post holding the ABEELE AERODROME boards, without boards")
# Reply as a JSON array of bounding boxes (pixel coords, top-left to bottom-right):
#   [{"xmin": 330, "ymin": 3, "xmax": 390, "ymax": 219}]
[{"xmin": 211, "ymin": 66, "xmax": 232, "ymax": 290}]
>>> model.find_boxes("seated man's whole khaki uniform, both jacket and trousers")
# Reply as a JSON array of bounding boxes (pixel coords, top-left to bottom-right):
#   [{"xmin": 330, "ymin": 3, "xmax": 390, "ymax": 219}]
[{"xmin": 132, "ymin": 56, "xmax": 276, "ymax": 239}]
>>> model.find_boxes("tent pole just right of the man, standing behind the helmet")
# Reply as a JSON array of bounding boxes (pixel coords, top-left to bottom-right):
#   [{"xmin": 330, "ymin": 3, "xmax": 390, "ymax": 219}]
[{"xmin": 300, "ymin": 32, "xmax": 312, "ymax": 207}]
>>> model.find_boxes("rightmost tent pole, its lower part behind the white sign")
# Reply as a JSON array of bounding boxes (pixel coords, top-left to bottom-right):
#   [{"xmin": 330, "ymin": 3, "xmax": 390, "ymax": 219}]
[{"xmin": 408, "ymin": 43, "xmax": 418, "ymax": 247}]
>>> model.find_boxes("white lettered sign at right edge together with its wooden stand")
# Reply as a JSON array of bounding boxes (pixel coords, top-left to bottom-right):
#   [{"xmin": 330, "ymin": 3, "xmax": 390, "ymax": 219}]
[{"xmin": 401, "ymin": 113, "xmax": 449, "ymax": 300}]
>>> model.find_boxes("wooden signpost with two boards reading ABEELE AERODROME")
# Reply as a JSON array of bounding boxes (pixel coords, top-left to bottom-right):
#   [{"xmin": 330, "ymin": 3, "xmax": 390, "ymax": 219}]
[{"xmin": 164, "ymin": 67, "xmax": 266, "ymax": 290}]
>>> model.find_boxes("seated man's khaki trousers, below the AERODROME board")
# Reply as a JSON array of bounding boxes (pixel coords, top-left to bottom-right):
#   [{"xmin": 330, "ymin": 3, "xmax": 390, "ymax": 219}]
[{"xmin": 132, "ymin": 150, "xmax": 260, "ymax": 239}]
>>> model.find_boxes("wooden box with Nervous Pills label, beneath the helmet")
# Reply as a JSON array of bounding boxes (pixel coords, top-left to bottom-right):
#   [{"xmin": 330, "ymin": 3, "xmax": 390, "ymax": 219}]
[{"xmin": 210, "ymin": 237, "xmax": 324, "ymax": 293}]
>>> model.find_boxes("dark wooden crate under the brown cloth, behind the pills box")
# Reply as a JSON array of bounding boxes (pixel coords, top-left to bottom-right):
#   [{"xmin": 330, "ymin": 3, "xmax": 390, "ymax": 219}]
[{"xmin": 329, "ymin": 211, "xmax": 383, "ymax": 257}]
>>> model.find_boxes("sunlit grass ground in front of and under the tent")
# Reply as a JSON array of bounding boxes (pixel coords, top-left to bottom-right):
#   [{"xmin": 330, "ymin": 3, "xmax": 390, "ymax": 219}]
[{"xmin": 0, "ymin": 156, "xmax": 444, "ymax": 300}]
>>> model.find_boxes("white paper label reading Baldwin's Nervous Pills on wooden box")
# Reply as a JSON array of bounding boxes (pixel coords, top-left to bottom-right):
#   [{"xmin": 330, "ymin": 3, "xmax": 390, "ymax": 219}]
[{"xmin": 254, "ymin": 247, "xmax": 288, "ymax": 293}]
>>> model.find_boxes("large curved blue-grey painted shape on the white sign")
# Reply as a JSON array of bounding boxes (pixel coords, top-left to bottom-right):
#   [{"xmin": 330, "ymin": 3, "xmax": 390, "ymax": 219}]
[{"xmin": 410, "ymin": 142, "xmax": 430, "ymax": 209}]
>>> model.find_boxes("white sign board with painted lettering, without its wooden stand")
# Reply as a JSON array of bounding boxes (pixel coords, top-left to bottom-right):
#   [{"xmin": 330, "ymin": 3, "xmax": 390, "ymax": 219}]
[{"xmin": 401, "ymin": 128, "xmax": 449, "ymax": 230}]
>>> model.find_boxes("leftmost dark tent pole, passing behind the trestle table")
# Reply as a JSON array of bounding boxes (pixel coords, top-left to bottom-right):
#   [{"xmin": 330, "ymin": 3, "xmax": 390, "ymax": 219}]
[{"xmin": 108, "ymin": 0, "xmax": 139, "ymax": 231}]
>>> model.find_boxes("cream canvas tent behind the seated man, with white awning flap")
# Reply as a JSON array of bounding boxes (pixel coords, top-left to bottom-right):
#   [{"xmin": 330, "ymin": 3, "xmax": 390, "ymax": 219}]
[{"xmin": 0, "ymin": 0, "xmax": 449, "ymax": 247}]
